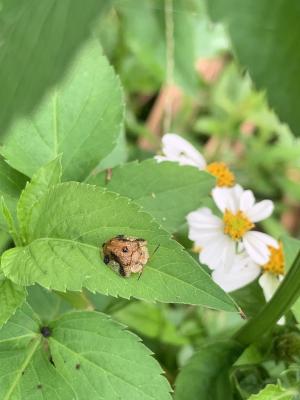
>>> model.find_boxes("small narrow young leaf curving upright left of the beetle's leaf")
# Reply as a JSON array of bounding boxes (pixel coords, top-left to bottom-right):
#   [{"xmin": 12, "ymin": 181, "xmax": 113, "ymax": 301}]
[{"xmin": 17, "ymin": 156, "xmax": 62, "ymax": 242}]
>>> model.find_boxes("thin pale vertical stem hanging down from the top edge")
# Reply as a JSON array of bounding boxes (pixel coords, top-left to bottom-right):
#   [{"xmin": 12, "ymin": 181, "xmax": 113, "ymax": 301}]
[{"xmin": 164, "ymin": 0, "xmax": 175, "ymax": 133}]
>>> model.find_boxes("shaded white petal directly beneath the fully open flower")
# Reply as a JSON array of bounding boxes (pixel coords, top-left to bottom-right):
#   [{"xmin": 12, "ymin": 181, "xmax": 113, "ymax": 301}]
[{"xmin": 212, "ymin": 255, "xmax": 261, "ymax": 292}]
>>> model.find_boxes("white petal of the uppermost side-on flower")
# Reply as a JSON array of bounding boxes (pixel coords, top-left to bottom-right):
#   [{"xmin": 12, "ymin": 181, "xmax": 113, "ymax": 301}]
[{"xmin": 162, "ymin": 133, "xmax": 206, "ymax": 169}]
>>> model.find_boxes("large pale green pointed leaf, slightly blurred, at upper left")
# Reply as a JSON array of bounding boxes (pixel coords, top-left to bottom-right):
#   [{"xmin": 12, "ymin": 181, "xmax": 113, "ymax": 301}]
[{"xmin": 1, "ymin": 39, "xmax": 123, "ymax": 180}]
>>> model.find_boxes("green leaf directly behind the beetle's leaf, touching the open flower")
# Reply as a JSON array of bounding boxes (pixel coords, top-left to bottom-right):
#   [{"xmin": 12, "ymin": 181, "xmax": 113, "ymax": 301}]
[{"xmin": 89, "ymin": 160, "xmax": 215, "ymax": 232}]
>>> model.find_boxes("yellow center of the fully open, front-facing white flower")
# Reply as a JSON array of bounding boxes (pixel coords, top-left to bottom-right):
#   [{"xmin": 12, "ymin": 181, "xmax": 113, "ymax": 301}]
[{"xmin": 223, "ymin": 210, "xmax": 255, "ymax": 240}]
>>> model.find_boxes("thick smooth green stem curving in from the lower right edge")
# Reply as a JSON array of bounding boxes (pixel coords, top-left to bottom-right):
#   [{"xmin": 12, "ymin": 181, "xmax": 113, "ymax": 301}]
[{"xmin": 234, "ymin": 252, "xmax": 300, "ymax": 345}]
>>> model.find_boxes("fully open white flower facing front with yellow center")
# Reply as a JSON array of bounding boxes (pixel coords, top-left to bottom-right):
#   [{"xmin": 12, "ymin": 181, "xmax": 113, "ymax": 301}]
[{"xmin": 187, "ymin": 185, "xmax": 278, "ymax": 269}]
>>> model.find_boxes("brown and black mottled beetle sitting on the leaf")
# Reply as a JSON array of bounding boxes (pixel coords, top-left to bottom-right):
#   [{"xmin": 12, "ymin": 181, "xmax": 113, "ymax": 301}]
[{"xmin": 102, "ymin": 235, "xmax": 149, "ymax": 277}]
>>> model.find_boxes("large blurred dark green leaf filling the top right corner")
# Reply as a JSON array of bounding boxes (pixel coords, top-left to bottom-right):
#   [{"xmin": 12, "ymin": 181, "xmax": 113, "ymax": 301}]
[{"xmin": 207, "ymin": 0, "xmax": 300, "ymax": 135}]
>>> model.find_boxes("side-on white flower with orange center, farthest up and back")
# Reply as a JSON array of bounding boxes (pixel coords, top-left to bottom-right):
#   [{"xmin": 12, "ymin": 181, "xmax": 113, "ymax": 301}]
[{"xmin": 155, "ymin": 133, "xmax": 235, "ymax": 188}]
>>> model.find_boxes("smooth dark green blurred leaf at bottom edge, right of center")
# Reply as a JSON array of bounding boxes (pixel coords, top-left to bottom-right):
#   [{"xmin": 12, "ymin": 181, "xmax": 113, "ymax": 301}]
[{"xmin": 175, "ymin": 341, "xmax": 242, "ymax": 400}]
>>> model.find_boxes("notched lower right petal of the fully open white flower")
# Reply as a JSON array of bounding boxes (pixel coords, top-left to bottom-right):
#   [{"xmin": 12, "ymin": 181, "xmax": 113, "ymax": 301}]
[{"xmin": 243, "ymin": 231, "xmax": 279, "ymax": 265}]
